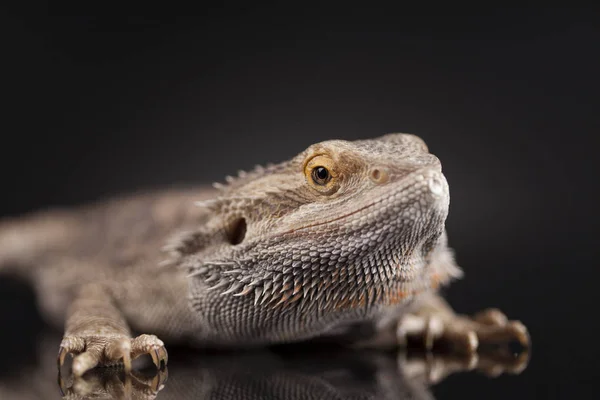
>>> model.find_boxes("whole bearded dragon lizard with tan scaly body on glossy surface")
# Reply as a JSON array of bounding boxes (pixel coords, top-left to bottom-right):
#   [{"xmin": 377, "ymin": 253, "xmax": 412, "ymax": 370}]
[{"xmin": 0, "ymin": 134, "xmax": 528, "ymax": 375}]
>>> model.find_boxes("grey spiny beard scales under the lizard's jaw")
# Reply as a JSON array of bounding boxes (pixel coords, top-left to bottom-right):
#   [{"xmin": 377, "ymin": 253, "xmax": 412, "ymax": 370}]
[{"xmin": 188, "ymin": 212, "xmax": 446, "ymax": 312}]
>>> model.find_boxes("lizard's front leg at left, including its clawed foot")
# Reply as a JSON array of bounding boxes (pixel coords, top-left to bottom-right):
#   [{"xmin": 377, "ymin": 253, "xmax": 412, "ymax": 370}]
[{"xmin": 58, "ymin": 285, "xmax": 167, "ymax": 376}]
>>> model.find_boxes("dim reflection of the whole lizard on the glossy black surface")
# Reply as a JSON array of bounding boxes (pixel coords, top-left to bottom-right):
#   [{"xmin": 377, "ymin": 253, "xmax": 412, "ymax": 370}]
[{"xmin": 0, "ymin": 331, "xmax": 525, "ymax": 400}]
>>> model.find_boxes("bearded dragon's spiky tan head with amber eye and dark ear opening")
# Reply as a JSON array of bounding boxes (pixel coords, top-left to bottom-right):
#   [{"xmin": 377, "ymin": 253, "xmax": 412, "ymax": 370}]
[{"xmin": 171, "ymin": 134, "xmax": 458, "ymax": 342}]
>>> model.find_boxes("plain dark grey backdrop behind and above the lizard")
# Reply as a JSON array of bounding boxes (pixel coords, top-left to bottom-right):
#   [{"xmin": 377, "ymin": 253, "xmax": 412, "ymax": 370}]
[{"xmin": 0, "ymin": 6, "xmax": 600, "ymax": 398}]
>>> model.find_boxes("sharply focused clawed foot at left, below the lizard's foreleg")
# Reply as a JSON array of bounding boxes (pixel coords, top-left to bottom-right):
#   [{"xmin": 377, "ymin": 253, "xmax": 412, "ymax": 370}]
[{"xmin": 58, "ymin": 335, "xmax": 168, "ymax": 376}]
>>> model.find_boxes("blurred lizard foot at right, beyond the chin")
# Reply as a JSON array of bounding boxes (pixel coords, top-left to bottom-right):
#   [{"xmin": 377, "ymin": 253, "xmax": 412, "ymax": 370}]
[{"xmin": 396, "ymin": 308, "xmax": 530, "ymax": 354}]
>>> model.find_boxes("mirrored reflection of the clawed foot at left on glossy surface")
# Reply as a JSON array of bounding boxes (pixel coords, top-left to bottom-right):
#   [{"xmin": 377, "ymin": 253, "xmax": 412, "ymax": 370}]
[{"xmin": 58, "ymin": 368, "xmax": 168, "ymax": 400}]
